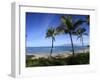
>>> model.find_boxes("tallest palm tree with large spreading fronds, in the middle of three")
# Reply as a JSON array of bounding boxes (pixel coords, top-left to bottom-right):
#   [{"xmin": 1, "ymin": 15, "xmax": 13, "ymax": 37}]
[{"xmin": 57, "ymin": 16, "xmax": 84, "ymax": 55}]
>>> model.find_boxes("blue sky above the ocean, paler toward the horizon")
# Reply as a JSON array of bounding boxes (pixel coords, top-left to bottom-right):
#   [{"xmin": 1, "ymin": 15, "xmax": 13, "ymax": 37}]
[{"xmin": 26, "ymin": 12, "xmax": 89, "ymax": 47}]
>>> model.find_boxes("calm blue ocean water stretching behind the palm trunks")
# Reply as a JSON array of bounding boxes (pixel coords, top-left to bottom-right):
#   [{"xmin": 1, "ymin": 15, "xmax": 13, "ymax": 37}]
[{"xmin": 26, "ymin": 46, "xmax": 88, "ymax": 54}]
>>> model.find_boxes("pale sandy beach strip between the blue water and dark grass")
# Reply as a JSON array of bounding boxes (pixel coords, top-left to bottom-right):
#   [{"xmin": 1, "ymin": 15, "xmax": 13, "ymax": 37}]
[{"xmin": 26, "ymin": 48, "xmax": 89, "ymax": 59}]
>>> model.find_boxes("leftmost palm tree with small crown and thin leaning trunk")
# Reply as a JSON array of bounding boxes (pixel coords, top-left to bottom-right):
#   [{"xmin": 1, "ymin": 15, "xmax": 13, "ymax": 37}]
[{"xmin": 46, "ymin": 27, "xmax": 57, "ymax": 58}]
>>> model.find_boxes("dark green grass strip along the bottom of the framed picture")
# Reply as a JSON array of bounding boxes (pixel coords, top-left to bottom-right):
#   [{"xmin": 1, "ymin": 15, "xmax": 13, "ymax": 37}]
[{"xmin": 26, "ymin": 53, "xmax": 90, "ymax": 67}]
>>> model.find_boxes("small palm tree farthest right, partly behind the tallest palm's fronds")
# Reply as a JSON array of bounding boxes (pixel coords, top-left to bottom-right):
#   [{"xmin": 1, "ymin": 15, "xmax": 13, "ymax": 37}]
[{"xmin": 76, "ymin": 28, "xmax": 88, "ymax": 53}]
